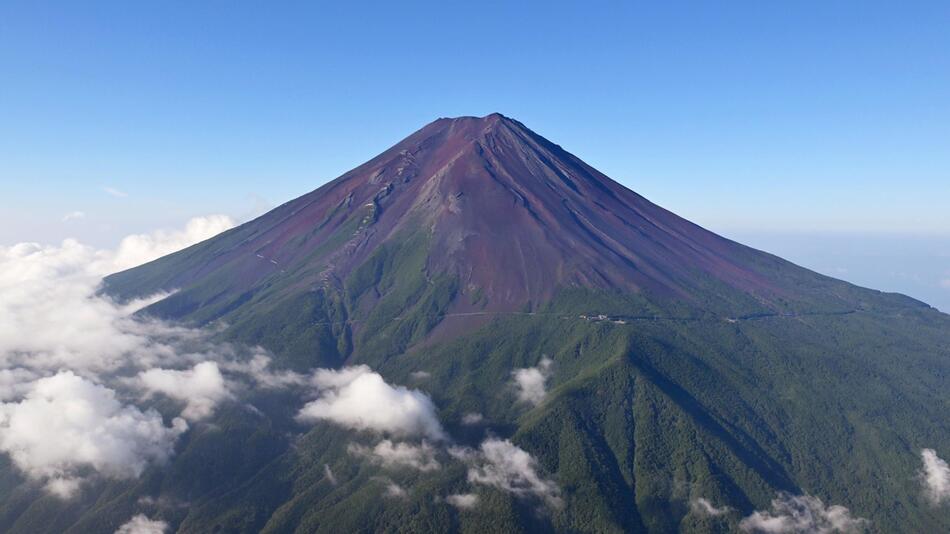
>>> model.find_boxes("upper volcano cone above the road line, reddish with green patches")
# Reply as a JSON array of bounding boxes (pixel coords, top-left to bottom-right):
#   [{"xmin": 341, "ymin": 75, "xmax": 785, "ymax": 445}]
[{"xmin": 107, "ymin": 114, "xmax": 917, "ymax": 368}]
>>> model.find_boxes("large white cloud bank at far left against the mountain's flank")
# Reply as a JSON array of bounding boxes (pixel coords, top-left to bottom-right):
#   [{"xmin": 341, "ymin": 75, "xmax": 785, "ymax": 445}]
[{"xmin": 0, "ymin": 216, "xmax": 233, "ymax": 498}]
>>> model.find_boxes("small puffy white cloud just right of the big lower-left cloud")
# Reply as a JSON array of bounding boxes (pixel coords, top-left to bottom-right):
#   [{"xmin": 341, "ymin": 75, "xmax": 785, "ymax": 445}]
[{"xmin": 138, "ymin": 362, "xmax": 231, "ymax": 421}]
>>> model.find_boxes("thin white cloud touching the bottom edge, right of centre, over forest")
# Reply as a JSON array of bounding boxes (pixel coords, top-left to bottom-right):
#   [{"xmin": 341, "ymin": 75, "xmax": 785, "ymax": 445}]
[{"xmin": 739, "ymin": 492, "xmax": 870, "ymax": 534}]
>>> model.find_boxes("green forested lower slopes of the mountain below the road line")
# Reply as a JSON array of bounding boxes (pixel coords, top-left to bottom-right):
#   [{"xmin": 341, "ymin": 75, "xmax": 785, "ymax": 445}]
[{"xmin": 0, "ymin": 278, "xmax": 950, "ymax": 532}]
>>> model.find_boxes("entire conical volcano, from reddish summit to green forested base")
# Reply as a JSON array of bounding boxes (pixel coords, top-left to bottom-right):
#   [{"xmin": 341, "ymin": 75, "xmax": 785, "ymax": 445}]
[{"xmin": 7, "ymin": 114, "xmax": 950, "ymax": 532}]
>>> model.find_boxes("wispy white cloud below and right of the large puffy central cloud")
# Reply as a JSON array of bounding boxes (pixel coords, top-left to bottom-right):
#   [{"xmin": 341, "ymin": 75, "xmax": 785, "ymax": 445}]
[{"xmin": 468, "ymin": 438, "xmax": 563, "ymax": 508}]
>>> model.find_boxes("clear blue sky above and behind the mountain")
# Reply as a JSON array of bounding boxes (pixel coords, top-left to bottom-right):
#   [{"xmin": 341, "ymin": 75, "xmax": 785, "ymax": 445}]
[{"xmin": 0, "ymin": 1, "xmax": 950, "ymax": 310}]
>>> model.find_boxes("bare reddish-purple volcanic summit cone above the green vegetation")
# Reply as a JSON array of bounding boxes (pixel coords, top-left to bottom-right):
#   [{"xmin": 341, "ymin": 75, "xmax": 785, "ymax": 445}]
[{"xmin": 244, "ymin": 114, "xmax": 780, "ymax": 305}]
